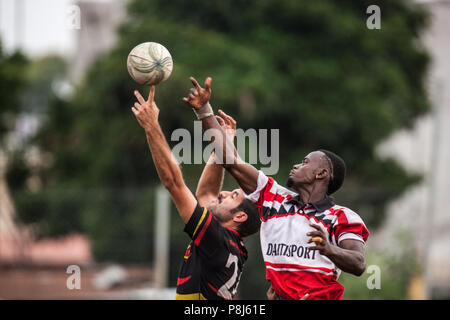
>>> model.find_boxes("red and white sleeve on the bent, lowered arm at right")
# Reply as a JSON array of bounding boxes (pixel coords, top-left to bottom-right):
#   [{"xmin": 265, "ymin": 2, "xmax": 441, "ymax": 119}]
[{"xmin": 332, "ymin": 208, "xmax": 370, "ymax": 244}]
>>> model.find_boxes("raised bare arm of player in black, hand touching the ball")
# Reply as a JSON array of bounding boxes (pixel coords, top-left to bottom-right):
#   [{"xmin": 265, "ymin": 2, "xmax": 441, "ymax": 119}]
[{"xmin": 132, "ymin": 86, "xmax": 197, "ymax": 223}]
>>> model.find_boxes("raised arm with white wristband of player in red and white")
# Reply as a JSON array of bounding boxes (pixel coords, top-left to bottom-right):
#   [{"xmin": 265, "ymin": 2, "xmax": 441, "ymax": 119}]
[{"xmin": 183, "ymin": 77, "xmax": 258, "ymax": 194}]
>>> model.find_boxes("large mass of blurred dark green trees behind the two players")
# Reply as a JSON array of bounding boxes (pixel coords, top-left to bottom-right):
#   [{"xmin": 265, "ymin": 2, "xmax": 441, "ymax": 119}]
[{"xmin": 5, "ymin": 0, "xmax": 429, "ymax": 298}]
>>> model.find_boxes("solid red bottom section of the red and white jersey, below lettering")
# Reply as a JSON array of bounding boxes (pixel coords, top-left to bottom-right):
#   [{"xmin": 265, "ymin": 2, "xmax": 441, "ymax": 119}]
[{"xmin": 267, "ymin": 269, "xmax": 344, "ymax": 300}]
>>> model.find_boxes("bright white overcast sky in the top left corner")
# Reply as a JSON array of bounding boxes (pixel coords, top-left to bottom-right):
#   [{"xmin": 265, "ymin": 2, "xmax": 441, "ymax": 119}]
[{"xmin": 0, "ymin": 0, "xmax": 75, "ymax": 57}]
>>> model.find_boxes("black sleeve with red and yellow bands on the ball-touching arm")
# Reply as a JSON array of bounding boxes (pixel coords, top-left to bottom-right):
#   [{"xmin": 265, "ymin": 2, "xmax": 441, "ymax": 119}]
[{"xmin": 184, "ymin": 203, "xmax": 223, "ymax": 255}]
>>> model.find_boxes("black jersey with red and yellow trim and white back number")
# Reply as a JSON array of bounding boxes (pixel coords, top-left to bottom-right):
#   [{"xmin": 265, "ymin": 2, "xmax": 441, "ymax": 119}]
[{"xmin": 176, "ymin": 204, "xmax": 248, "ymax": 300}]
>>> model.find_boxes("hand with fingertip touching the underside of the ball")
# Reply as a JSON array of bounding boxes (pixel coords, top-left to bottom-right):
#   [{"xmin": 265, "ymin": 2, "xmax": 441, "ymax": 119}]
[{"xmin": 131, "ymin": 86, "xmax": 159, "ymax": 130}]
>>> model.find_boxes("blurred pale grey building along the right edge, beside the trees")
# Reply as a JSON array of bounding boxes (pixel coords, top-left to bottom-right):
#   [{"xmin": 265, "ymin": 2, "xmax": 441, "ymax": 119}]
[{"xmin": 372, "ymin": 0, "xmax": 450, "ymax": 298}]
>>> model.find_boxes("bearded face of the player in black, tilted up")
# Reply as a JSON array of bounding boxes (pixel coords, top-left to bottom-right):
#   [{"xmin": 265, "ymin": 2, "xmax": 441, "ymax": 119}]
[{"xmin": 209, "ymin": 189, "xmax": 245, "ymax": 222}]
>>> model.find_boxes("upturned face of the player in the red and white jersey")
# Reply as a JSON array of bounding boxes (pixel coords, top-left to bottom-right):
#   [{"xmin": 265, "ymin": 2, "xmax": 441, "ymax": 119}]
[{"xmin": 286, "ymin": 151, "xmax": 323, "ymax": 188}]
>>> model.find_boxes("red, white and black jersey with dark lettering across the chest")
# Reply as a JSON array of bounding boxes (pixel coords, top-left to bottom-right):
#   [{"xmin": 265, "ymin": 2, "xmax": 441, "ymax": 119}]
[{"xmin": 245, "ymin": 171, "xmax": 369, "ymax": 300}]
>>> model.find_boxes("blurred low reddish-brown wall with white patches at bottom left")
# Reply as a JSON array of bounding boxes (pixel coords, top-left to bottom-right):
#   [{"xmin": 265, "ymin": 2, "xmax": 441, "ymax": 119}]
[{"xmin": 0, "ymin": 264, "xmax": 158, "ymax": 300}]
